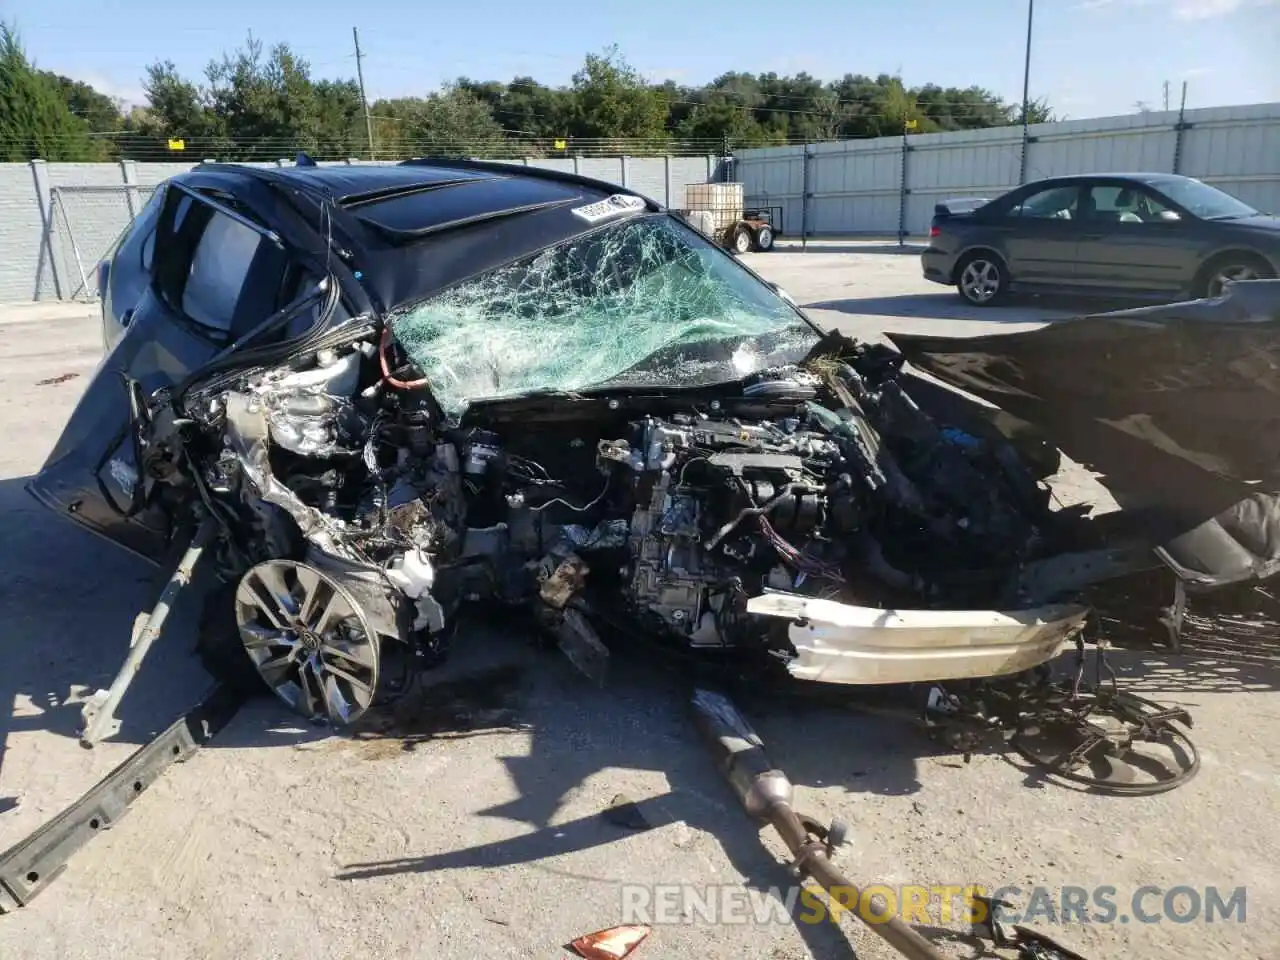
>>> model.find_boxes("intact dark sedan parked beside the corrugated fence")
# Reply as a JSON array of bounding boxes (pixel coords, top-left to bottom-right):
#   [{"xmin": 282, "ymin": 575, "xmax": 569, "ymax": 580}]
[{"xmin": 920, "ymin": 173, "xmax": 1280, "ymax": 306}]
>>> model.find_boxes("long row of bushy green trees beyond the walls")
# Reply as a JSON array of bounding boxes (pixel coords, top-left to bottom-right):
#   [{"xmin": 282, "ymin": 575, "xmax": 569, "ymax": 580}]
[{"xmin": 122, "ymin": 36, "xmax": 1053, "ymax": 160}]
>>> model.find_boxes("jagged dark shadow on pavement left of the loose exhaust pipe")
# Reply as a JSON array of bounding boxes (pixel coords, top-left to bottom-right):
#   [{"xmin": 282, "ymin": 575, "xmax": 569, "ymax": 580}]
[{"xmin": 335, "ymin": 640, "xmax": 875, "ymax": 960}]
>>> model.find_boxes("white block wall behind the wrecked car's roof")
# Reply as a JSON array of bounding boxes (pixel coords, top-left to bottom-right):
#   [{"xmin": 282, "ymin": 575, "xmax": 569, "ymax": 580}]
[{"xmin": 0, "ymin": 156, "xmax": 723, "ymax": 303}]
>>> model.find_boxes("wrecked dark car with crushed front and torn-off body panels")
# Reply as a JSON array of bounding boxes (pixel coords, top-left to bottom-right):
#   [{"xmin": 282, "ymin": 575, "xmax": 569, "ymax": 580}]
[{"xmin": 28, "ymin": 160, "xmax": 1280, "ymax": 762}]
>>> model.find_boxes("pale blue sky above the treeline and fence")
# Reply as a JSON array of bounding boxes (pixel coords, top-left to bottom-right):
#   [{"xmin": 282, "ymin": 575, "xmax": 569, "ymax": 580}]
[{"xmin": 10, "ymin": 0, "xmax": 1280, "ymax": 118}]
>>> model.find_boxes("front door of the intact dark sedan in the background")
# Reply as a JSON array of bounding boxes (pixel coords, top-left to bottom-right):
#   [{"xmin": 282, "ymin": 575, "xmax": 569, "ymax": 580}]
[{"xmin": 1076, "ymin": 180, "xmax": 1197, "ymax": 293}]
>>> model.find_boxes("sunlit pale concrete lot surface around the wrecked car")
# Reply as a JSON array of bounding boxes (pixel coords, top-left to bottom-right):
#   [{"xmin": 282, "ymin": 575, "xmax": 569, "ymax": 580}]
[{"xmin": 0, "ymin": 252, "xmax": 1280, "ymax": 960}]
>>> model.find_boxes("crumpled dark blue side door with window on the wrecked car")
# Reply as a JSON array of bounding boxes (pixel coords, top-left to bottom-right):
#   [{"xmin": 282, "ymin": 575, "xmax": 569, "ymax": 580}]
[{"xmin": 27, "ymin": 182, "xmax": 312, "ymax": 561}]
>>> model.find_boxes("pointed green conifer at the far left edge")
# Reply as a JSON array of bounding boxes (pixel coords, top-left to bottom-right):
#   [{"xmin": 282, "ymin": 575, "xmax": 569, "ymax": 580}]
[{"xmin": 0, "ymin": 24, "xmax": 102, "ymax": 163}]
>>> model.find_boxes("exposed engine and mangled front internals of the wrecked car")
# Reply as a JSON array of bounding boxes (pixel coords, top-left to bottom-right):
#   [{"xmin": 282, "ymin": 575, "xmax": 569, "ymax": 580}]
[{"xmin": 167, "ymin": 323, "xmax": 1050, "ymax": 701}]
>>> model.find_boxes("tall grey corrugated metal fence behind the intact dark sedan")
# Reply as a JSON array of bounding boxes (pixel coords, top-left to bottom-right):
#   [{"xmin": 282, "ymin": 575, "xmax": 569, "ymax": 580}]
[{"xmin": 736, "ymin": 104, "xmax": 1280, "ymax": 237}]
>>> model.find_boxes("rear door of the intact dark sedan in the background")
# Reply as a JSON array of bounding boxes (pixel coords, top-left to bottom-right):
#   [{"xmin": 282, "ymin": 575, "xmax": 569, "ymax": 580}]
[{"xmin": 998, "ymin": 182, "xmax": 1083, "ymax": 287}]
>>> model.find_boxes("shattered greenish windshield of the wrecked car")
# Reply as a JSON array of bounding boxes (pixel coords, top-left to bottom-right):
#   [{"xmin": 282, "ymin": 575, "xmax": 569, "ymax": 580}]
[{"xmin": 390, "ymin": 215, "xmax": 818, "ymax": 413}]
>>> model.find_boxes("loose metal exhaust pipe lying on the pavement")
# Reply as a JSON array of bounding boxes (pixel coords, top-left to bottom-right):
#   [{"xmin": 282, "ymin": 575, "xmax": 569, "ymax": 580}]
[{"xmin": 692, "ymin": 690, "xmax": 945, "ymax": 960}]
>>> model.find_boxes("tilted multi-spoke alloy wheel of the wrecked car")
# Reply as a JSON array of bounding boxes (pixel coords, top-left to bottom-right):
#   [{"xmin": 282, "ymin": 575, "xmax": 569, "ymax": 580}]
[{"xmin": 236, "ymin": 559, "xmax": 379, "ymax": 724}]
